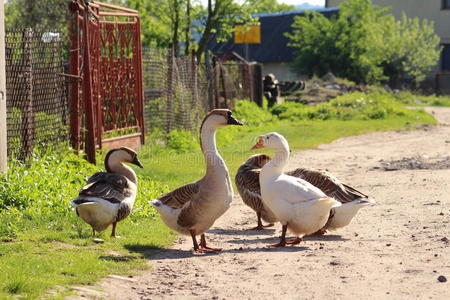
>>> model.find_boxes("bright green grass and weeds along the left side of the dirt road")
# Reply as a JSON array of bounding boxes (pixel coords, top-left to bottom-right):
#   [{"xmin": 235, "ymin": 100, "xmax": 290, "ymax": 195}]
[{"xmin": 0, "ymin": 90, "xmax": 435, "ymax": 299}]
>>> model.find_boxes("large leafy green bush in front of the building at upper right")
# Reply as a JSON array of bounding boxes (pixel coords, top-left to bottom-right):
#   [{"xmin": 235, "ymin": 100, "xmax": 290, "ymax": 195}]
[{"xmin": 286, "ymin": 0, "xmax": 439, "ymax": 83}]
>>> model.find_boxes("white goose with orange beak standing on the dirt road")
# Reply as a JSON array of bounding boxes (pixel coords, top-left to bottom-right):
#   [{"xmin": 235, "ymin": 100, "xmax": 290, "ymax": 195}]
[{"xmin": 252, "ymin": 132, "xmax": 341, "ymax": 247}]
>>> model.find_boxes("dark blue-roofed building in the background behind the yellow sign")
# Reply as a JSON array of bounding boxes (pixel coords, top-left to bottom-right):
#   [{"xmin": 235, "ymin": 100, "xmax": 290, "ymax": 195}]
[{"xmin": 207, "ymin": 8, "xmax": 338, "ymax": 81}]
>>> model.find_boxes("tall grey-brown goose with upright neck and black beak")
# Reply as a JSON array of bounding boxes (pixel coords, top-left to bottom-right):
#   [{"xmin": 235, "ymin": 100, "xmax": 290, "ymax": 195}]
[{"xmin": 149, "ymin": 109, "xmax": 243, "ymax": 253}]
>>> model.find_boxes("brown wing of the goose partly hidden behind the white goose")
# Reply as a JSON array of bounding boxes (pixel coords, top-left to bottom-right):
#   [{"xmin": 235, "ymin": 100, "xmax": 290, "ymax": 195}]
[{"xmin": 286, "ymin": 168, "xmax": 368, "ymax": 203}]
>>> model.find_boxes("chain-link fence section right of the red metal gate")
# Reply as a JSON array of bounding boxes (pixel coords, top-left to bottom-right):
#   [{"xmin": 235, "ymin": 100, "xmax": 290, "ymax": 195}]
[{"xmin": 142, "ymin": 48, "xmax": 206, "ymax": 133}]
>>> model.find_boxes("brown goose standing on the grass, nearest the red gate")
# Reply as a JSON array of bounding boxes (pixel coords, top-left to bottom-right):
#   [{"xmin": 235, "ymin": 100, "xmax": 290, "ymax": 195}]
[{"xmin": 71, "ymin": 147, "xmax": 143, "ymax": 238}]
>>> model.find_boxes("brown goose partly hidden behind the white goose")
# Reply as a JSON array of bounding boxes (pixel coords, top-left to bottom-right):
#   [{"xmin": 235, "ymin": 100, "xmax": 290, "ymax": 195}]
[{"xmin": 236, "ymin": 154, "xmax": 375, "ymax": 234}]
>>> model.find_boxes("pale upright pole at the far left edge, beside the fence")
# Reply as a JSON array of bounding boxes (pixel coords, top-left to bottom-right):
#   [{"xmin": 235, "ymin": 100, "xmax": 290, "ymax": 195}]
[{"xmin": 0, "ymin": 0, "xmax": 8, "ymax": 173}]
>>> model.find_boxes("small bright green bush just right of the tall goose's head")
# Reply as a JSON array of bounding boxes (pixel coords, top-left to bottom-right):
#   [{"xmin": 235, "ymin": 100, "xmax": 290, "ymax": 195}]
[{"xmin": 233, "ymin": 100, "xmax": 275, "ymax": 126}]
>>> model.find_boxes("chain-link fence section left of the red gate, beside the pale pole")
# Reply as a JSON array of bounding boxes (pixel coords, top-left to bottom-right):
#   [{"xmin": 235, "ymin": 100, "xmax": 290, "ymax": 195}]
[{"xmin": 5, "ymin": 29, "xmax": 68, "ymax": 160}]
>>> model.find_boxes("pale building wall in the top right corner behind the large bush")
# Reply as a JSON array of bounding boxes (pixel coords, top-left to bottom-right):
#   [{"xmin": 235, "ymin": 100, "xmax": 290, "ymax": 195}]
[{"xmin": 325, "ymin": 0, "xmax": 450, "ymax": 72}]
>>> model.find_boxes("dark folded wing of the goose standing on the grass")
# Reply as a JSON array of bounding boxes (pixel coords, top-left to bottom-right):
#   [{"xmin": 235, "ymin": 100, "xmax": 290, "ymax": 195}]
[{"xmin": 74, "ymin": 172, "xmax": 133, "ymax": 204}]
